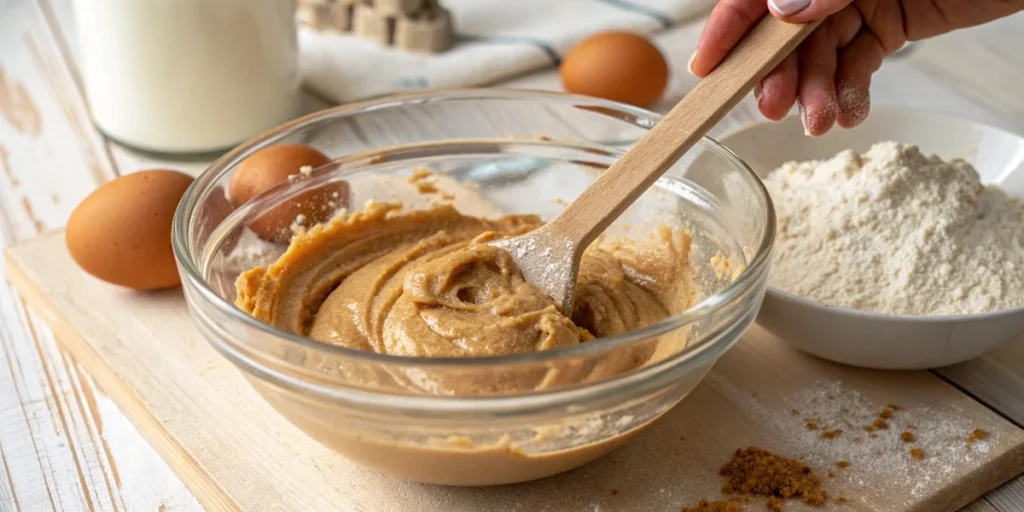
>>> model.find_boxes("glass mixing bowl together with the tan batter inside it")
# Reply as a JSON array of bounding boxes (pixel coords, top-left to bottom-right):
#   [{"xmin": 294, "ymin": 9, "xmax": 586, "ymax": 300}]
[{"xmin": 174, "ymin": 90, "xmax": 774, "ymax": 485}]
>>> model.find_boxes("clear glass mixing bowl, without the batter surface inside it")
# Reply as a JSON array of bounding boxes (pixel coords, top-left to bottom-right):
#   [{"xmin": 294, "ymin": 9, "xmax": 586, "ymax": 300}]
[{"xmin": 173, "ymin": 89, "xmax": 775, "ymax": 485}]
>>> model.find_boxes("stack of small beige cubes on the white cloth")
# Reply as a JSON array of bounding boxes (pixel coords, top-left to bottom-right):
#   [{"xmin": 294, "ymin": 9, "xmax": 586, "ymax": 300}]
[{"xmin": 302, "ymin": 0, "xmax": 453, "ymax": 53}]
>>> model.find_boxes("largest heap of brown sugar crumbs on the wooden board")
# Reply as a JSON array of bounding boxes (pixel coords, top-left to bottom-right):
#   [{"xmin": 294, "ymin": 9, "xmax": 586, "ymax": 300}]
[{"xmin": 720, "ymin": 446, "xmax": 828, "ymax": 505}]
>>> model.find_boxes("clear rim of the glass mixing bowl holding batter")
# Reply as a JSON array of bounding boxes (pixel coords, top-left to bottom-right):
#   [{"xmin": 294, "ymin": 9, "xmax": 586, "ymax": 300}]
[{"xmin": 171, "ymin": 88, "xmax": 775, "ymax": 370}]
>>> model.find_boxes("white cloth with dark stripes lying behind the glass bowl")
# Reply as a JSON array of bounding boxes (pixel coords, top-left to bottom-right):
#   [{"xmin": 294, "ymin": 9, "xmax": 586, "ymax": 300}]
[{"xmin": 299, "ymin": 0, "xmax": 716, "ymax": 102}]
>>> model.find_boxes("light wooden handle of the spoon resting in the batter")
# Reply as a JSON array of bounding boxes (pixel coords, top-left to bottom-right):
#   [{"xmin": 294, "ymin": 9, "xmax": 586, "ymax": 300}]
[{"xmin": 545, "ymin": 14, "xmax": 820, "ymax": 247}]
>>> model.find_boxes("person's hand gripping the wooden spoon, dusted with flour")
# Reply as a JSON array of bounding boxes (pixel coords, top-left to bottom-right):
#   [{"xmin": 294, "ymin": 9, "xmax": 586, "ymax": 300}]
[{"xmin": 689, "ymin": 0, "xmax": 1024, "ymax": 136}]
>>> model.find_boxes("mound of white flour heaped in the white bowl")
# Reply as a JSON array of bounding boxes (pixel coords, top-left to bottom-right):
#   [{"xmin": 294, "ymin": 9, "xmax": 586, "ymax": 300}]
[{"xmin": 765, "ymin": 142, "xmax": 1024, "ymax": 315}]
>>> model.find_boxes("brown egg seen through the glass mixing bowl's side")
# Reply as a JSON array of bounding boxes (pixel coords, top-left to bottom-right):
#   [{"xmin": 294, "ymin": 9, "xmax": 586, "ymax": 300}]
[{"xmin": 228, "ymin": 144, "xmax": 348, "ymax": 244}]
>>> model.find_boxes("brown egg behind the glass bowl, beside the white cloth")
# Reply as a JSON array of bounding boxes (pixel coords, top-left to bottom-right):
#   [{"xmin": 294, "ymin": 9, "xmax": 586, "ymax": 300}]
[{"xmin": 560, "ymin": 32, "xmax": 669, "ymax": 106}]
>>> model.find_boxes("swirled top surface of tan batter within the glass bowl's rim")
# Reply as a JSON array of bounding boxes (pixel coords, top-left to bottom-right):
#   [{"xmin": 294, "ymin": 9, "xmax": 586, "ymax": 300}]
[{"xmin": 237, "ymin": 203, "xmax": 692, "ymax": 382}]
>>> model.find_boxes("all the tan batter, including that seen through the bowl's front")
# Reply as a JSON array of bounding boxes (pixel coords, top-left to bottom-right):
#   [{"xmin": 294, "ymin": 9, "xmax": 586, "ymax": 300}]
[{"xmin": 237, "ymin": 198, "xmax": 695, "ymax": 485}]
